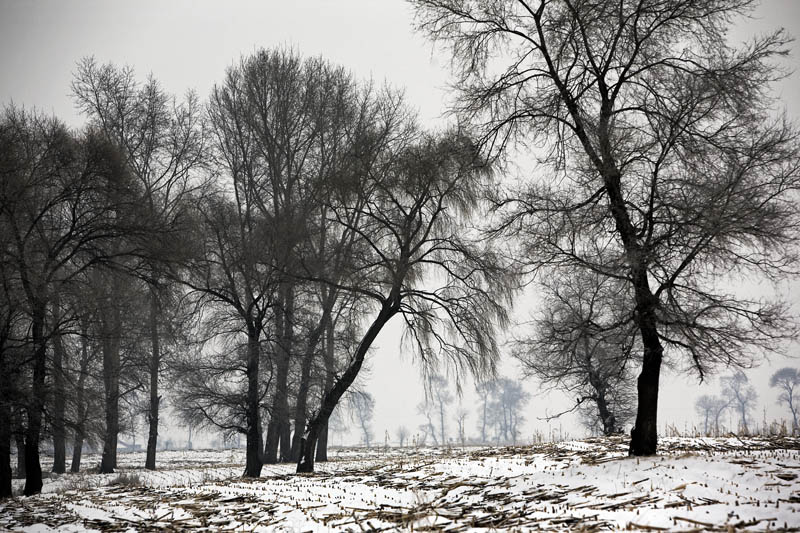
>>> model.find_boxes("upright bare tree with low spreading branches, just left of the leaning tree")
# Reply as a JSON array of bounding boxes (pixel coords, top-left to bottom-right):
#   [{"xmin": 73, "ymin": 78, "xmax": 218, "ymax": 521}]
[{"xmin": 176, "ymin": 188, "xmax": 278, "ymax": 477}]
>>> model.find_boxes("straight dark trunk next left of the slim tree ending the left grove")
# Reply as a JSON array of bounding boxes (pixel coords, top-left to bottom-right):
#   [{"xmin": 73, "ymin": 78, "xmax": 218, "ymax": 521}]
[{"xmin": 100, "ymin": 302, "xmax": 121, "ymax": 474}]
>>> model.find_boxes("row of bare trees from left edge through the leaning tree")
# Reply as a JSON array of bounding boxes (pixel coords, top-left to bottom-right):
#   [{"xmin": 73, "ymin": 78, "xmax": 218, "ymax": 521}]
[{"xmin": 0, "ymin": 49, "xmax": 511, "ymax": 495}]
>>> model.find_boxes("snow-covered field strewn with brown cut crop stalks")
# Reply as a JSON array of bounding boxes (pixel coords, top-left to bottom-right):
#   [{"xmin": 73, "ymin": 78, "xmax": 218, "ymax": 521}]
[{"xmin": 0, "ymin": 437, "xmax": 800, "ymax": 532}]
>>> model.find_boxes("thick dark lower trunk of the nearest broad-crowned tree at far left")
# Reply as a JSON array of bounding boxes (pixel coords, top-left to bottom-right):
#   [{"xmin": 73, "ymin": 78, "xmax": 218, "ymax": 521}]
[{"xmin": 22, "ymin": 303, "xmax": 47, "ymax": 496}]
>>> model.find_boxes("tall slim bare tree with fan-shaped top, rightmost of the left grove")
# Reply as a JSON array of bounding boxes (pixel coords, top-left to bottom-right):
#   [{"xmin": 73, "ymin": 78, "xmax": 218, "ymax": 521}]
[{"xmin": 72, "ymin": 58, "xmax": 206, "ymax": 470}]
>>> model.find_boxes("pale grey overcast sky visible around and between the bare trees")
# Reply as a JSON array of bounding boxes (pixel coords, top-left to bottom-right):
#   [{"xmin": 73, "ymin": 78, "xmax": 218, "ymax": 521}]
[{"xmin": 0, "ymin": 0, "xmax": 800, "ymax": 442}]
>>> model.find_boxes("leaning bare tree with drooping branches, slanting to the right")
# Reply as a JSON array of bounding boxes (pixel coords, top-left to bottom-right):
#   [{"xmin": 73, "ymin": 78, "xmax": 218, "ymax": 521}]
[{"xmin": 298, "ymin": 128, "xmax": 509, "ymax": 472}]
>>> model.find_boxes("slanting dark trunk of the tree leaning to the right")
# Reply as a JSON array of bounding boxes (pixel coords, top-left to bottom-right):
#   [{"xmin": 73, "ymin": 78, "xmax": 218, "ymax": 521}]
[{"xmin": 297, "ymin": 298, "xmax": 400, "ymax": 473}]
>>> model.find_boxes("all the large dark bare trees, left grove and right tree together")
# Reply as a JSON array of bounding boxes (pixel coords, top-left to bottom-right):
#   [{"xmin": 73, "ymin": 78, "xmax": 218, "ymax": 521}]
[{"xmin": 0, "ymin": 0, "xmax": 800, "ymax": 495}]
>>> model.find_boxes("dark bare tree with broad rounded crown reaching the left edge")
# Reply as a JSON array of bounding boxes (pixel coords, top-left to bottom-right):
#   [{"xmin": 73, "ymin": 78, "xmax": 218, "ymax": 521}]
[{"xmin": 0, "ymin": 108, "xmax": 152, "ymax": 494}]
